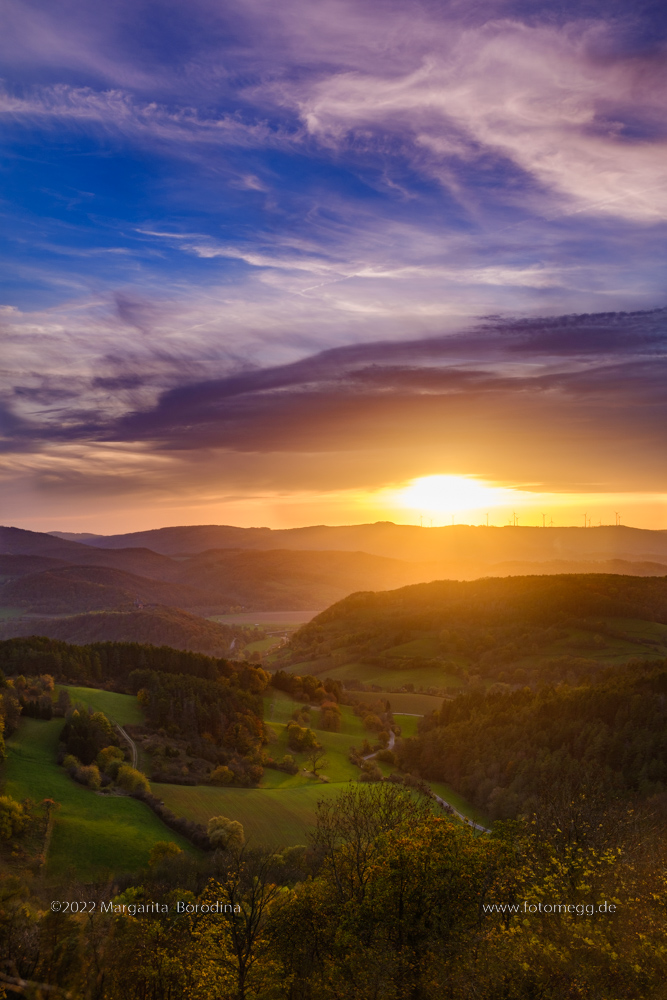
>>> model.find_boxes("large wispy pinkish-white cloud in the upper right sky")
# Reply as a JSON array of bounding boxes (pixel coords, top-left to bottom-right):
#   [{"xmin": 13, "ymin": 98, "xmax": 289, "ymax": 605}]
[{"xmin": 260, "ymin": 20, "xmax": 667, "ymax": 222}]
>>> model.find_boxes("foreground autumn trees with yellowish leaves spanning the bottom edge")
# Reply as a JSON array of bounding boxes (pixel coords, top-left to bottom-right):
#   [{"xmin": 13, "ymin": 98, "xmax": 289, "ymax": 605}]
[{"xmin": 0, "ymin": 783, "xmax": 667, "ymax": 1000}]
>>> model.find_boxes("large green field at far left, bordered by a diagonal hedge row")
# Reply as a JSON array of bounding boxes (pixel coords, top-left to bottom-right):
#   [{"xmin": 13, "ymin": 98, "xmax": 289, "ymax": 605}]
[{"xmin": 2, "ymin": 718, "xmax": 194, "ymax": 881}]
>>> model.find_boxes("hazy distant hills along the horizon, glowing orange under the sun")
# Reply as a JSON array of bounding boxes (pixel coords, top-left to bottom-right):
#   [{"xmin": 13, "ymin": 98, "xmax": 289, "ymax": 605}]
[{"xmin": 0, "ymin": 522, "xmax": 667, "ymax": 655}]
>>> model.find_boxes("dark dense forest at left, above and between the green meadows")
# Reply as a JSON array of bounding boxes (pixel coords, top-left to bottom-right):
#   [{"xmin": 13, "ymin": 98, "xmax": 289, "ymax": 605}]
[{"xmin": 0, "ymin": 636, "xmax": 269, "ymax": 786}]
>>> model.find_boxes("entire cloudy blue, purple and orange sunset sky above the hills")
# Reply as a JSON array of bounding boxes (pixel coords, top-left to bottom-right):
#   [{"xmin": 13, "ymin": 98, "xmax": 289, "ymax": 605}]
[{"xmin": 0, "ymin": 0, "xmax": 667, "ymax": 533}]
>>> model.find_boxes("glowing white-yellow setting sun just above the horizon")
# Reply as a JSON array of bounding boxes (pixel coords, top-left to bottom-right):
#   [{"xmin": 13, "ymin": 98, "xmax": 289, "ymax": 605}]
[{"xmin": 395, "ymin": 476, "xmax": 516, "ymax": 514}]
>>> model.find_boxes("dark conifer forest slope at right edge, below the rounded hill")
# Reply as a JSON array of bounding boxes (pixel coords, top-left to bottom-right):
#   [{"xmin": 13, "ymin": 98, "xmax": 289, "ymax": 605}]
[{"xmin": 399, "ymin": 661, "xmax": 667, "ymax": 818}]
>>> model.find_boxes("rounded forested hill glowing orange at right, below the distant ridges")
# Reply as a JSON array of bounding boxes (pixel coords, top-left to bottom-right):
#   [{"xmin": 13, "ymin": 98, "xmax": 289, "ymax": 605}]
[{"xmin": 279, "ymin": 574, "xmax": 667, "ymax": 685}]
